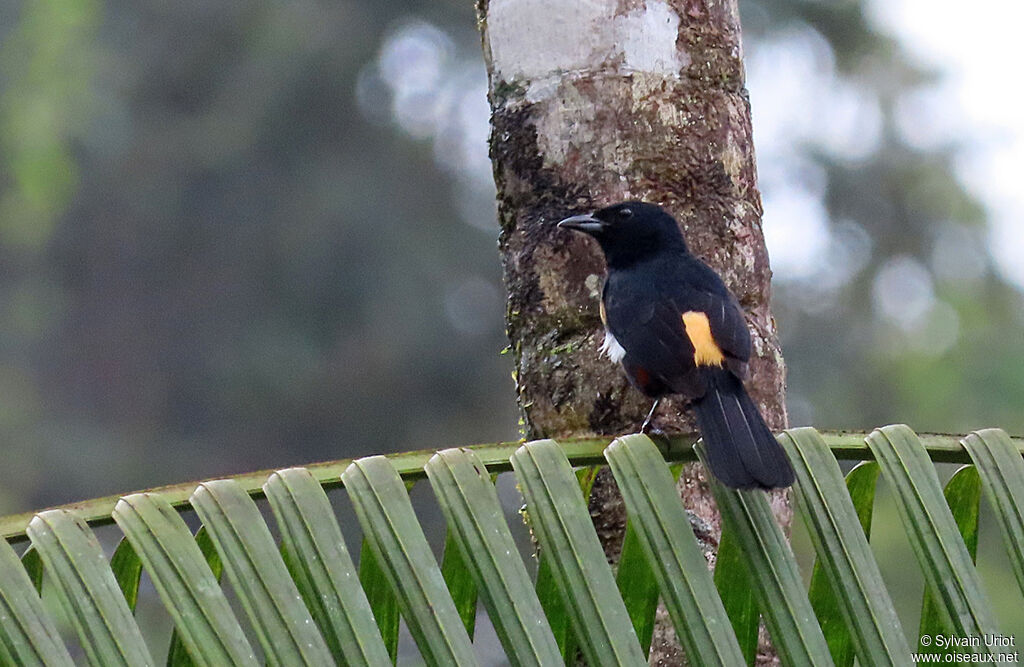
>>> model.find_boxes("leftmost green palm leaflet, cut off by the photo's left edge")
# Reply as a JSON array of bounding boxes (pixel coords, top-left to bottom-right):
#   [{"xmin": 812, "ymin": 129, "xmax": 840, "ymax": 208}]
[{"xmin": 0, "ymin": 540, "xmax": 75, "ymax": 667}]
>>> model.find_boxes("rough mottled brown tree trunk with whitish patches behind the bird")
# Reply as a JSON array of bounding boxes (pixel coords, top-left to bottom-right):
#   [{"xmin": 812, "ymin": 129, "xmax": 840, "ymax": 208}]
[{"xmin": 477, "ymin": 0, "xmax": 788, "ymax": 664}]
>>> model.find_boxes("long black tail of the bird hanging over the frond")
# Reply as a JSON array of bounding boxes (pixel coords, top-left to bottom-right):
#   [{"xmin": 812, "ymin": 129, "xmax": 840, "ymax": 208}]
[{"xmin": 694, "ymin": 367, "xmax": 794, "ymax": 489}]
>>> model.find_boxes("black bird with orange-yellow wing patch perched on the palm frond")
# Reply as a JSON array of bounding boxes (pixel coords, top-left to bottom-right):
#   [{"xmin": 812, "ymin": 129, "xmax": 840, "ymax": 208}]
[{"xmin": 558, "ymin": 202, "xmax": 794, "ymax": 489}]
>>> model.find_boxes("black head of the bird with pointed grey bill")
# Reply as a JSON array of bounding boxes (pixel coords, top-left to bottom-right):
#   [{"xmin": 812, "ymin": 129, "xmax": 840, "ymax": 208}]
[{"xmin": 558, "ymin": 202, "xmax": 686, "ymax": 266}]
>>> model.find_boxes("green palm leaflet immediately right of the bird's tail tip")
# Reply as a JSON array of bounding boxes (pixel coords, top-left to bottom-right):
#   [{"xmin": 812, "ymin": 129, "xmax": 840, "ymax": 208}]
[{"xmin": 773, "ymin": 428, "xmax": 910, "ymax": 665}]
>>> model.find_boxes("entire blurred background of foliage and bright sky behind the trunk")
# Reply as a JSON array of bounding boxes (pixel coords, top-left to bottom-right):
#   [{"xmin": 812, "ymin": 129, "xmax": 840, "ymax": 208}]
[{"xmin": 0, "ymin": 0, "xmax": 1024, "ymax": 651}]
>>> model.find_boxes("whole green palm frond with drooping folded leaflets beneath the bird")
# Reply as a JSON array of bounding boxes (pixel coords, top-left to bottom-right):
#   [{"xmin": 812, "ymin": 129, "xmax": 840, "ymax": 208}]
[{"xmin": 0, "ymin": 426, "xmax": 1024, "ymax": 666}]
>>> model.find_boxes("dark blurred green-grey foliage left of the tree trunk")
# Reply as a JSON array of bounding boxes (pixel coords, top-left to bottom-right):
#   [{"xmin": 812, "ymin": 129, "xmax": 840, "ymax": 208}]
[{"xmin": 0, "ymin": 0, "xmax": 516, "ymax": 513}]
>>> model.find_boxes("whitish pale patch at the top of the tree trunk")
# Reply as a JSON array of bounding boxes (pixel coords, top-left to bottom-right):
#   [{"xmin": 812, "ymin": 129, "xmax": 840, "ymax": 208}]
[{"xmin": 487, "ymin": 0, "xmax": 689, "ymax": 96}]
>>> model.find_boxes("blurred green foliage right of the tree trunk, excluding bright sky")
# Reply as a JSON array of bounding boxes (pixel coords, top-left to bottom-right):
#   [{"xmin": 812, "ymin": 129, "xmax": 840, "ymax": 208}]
[{"xmin": 741, "ymin": 0, "xmax": 1024, "ymax": 433}]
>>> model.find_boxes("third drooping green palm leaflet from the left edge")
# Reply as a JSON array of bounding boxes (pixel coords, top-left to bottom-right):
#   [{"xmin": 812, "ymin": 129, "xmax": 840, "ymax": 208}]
[{"xmin": 113, "ymin": 494, "xmax": 256, "ymax": 665}]
